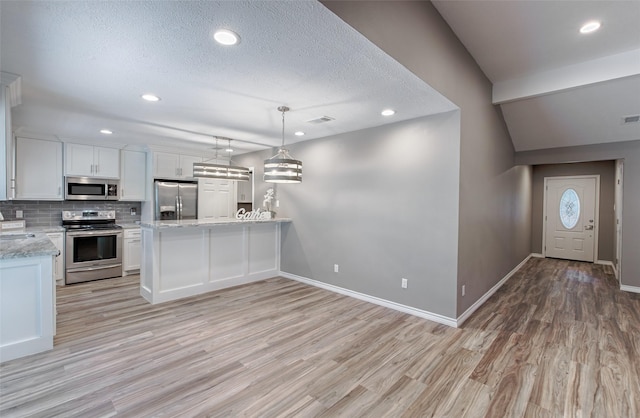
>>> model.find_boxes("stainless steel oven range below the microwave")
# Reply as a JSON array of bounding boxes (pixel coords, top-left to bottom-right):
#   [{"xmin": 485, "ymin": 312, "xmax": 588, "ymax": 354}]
[{"xmin": 62, "ymin": 210, "xmax": 122, "ymax": 284}]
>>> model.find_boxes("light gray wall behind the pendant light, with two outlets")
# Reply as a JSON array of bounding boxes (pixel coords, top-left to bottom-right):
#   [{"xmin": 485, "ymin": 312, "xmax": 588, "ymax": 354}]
[{"xmin": 236, "ymin": 111, "xmax": 460, "ymax": 318}]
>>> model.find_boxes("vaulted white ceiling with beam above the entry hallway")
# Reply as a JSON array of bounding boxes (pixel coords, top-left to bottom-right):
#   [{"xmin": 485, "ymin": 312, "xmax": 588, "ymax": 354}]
[{"xmin": 433, "ymin": 0, "xmax": 640, "ymax": 151}]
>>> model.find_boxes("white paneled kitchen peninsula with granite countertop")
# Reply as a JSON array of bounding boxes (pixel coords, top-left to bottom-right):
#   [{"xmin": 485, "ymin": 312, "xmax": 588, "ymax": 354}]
[{"xmin": 140, "ymin": 218, "xmax": 291, "ymax": 304}]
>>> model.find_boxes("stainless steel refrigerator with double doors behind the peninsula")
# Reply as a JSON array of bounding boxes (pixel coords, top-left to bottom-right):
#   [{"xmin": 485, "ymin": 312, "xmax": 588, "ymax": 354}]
[{"xmin": 154, "ymin": 180, "xmax": 198, "ymax": 221}]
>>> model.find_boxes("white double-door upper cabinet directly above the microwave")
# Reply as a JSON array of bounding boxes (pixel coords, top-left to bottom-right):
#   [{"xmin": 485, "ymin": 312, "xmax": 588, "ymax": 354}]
[{"xmin": 64, "ymin": 143, "xmax": 120, "ymax": 179}]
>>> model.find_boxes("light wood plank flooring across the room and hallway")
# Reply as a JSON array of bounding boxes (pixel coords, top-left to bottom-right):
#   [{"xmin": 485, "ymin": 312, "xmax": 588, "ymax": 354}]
[{"xmin": 0, "ymin": 259, "xmax": 640, "ymax": 418}]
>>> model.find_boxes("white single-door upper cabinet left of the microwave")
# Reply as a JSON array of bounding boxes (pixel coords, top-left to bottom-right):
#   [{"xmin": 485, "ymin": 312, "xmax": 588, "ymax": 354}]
[{"xmin": 15, "ymin": 137, "xmax": 64, "ymax": 200}]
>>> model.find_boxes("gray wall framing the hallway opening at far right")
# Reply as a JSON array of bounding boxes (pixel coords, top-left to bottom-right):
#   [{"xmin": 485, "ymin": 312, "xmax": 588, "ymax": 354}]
[{"xmin": 516, "ymin": 140, "xmax": 640, "ymax": 288}]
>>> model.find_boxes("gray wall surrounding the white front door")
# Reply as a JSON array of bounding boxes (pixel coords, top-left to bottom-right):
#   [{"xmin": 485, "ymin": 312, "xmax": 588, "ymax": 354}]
[{"xmin": 531, "ymin": 161, "xmax": 615, "ymax": 261}]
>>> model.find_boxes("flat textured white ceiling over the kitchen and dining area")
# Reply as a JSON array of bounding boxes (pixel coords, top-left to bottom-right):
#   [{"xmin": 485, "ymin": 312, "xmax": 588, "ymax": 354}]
[{"xmin": 0, "ymin": 0, "xmax": 455, "ymax": 152}]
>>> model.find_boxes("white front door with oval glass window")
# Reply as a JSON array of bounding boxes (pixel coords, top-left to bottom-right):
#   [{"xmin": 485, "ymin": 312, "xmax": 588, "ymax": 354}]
[{"xmin": 544, "ymin": 176, "xmax": 599, "ymax": 262}]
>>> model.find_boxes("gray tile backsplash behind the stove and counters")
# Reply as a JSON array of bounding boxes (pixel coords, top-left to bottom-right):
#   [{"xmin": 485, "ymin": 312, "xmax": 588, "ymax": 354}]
[{"xmin": 0, "ymin": 200, "xmax": 141, "ymax": 228}]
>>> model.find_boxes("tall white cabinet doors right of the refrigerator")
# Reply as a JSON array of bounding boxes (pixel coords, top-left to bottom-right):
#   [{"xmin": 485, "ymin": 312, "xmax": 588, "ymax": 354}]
[{"xmin": 198, "ymin": 178, "xmax": 237, "ymax": 220}]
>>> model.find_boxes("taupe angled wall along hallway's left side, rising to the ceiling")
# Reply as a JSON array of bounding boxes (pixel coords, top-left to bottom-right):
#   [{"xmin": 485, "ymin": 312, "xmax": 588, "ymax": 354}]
[{"xmin": 323, "ymin": 1, "xmax": 531, "ymax": 315}]
